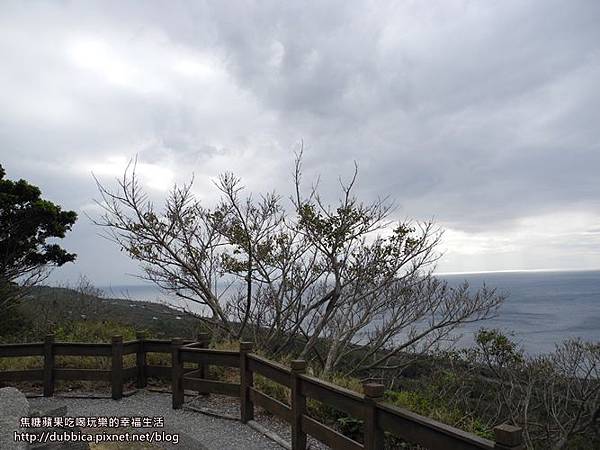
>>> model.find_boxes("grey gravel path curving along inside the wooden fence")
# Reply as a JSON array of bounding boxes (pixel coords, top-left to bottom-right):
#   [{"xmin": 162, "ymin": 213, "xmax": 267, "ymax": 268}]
[{"xmin": 29, "ymin": 391, "xmax": 282, "ymax": 450}]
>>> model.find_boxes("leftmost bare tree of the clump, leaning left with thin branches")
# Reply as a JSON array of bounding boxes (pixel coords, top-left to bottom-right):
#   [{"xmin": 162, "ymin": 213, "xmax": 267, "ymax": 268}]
[{"xmin": 94, "ymin": 163, "xmax": 233, "ymax": 334}]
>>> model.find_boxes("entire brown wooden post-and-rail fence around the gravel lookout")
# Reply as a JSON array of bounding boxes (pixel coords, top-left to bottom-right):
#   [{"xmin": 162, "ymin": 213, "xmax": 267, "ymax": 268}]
[{"xmin": 0, "ymin": 333, "xmax": 524, "ymax": 450}]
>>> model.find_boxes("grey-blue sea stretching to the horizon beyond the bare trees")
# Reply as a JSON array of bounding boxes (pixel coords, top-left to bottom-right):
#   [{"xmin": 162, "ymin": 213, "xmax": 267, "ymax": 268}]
[{"xmin": 103, "ymin": 271, "xmax": 600, "ymax": 354}]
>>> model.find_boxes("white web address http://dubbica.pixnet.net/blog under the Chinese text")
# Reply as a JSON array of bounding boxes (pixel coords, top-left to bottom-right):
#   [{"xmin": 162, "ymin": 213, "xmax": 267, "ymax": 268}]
[{"xmin": 14, "ymin": 431, "xmax": 179, "ymax": 445}]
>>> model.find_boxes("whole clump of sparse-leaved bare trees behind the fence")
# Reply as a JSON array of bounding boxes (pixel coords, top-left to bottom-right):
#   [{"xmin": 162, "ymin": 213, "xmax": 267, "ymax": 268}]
[{"xmin": 95, "ymin": 152, "xmax": 501, "ymax": 372}]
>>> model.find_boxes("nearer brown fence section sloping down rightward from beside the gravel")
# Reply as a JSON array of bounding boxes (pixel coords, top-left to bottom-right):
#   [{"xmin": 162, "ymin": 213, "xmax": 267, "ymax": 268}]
[{"xmin": 172, "ymin": 342, "xmax": 524, "ymax": 450}]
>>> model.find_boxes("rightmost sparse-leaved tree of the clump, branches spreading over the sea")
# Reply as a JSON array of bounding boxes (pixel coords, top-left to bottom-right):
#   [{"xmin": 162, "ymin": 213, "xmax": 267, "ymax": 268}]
[{"xmin": 282, "ymin": 153, "xmax": 502, "ymax": 373}]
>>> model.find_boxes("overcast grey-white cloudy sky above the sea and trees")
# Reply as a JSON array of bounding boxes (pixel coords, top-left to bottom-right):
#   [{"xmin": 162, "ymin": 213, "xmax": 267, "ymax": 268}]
[{"xmin": 0, "ymin": 0, "xmax": 600, "ymax": 285}]
